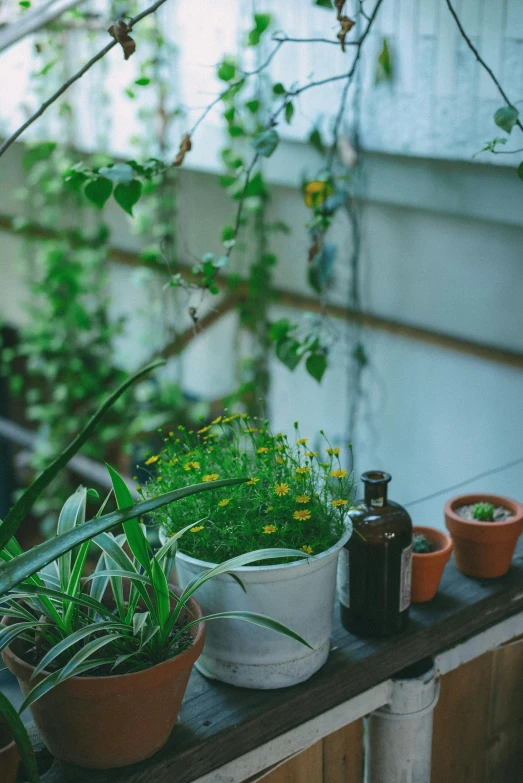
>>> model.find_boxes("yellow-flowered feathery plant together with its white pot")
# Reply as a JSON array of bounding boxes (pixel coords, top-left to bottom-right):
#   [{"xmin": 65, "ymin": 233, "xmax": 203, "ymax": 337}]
[{"xmin": 145, "ymin": 413, "xmax": 354, "ymax": 688}]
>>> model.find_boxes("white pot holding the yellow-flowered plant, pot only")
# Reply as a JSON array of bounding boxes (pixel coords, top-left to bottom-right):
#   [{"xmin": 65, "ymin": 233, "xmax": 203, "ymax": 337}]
[{"xmin": 172, "ymin": 531, "xmax": 350, "ymax": 689}]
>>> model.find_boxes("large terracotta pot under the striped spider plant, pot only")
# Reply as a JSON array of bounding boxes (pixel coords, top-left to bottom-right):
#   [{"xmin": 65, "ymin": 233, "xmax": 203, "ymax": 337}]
[{"xmin": 2, "ymin": 588, "xmax": 205, "ymax": 768}]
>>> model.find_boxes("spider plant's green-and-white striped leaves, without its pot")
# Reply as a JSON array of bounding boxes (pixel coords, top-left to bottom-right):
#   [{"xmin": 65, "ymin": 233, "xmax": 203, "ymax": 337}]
[{"xmin": 0, "ymin": 466, "xmax": 310, "ymax": 710}]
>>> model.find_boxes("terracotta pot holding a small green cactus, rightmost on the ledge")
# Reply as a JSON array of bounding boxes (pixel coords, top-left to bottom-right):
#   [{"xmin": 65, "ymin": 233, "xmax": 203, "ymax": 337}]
[{"xmin": 445, "ymin": 493, "xmax": 523, "ymax": 579}]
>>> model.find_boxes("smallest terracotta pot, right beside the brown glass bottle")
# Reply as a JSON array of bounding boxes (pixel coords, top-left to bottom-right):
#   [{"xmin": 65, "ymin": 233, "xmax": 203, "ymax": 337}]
[{"xmin": 411, "ymin": 525, "xmax": 452, "ymax": 604}]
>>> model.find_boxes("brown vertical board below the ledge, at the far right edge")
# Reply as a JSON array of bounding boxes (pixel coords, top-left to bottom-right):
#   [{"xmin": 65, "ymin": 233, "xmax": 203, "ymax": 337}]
[{"xmin": 487, "ymin": 639, "xmax": 523, "ymax": 783}]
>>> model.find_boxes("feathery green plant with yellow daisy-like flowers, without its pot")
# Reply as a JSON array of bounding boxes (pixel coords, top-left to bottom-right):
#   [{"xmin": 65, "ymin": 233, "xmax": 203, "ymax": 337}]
[{"xmin": 143, "ymin": 413, "xmax": 354, "ymax": 563}]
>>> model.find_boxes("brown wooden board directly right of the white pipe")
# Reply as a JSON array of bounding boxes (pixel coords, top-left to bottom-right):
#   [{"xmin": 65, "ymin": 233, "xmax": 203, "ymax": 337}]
[{"xmin": 431, "ymin": 653, "xmax": 492, "ymax": 783}]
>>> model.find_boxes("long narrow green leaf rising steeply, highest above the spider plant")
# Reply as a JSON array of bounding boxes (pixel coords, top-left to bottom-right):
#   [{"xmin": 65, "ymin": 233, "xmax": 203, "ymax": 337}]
[{"xmin": 0, "ymin": 359, "xmax": 165, "ymax": 548}]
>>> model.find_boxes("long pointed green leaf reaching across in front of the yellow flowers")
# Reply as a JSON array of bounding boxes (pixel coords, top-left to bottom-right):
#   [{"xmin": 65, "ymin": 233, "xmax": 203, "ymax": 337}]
[{"xmin": 0, "ymin": 478, "xmax": 250, "ymax": 595}]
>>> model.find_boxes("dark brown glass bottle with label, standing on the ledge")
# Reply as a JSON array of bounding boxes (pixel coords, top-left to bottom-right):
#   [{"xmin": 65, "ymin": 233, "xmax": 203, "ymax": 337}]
[{"xmin": 338, "ymin": 470, "xmax": 412, "ymax": 636}]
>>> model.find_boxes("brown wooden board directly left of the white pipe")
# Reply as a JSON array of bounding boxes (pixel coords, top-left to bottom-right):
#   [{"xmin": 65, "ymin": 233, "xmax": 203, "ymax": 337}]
[{"xmin": 323, "ymin": 720, "xmax": 364, "ymax": 783}]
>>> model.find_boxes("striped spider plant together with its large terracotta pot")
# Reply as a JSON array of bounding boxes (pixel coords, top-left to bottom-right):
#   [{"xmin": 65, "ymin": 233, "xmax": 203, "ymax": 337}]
[{"xmin": 0, "ymin": 469, "xmax": 307, "ymax": 769}]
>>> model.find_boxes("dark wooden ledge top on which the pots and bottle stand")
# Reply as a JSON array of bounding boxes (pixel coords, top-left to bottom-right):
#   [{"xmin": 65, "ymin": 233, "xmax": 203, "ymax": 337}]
[{"xmin": 34, "ymin": 538, "xmax": 523, "ymax": 783}]
